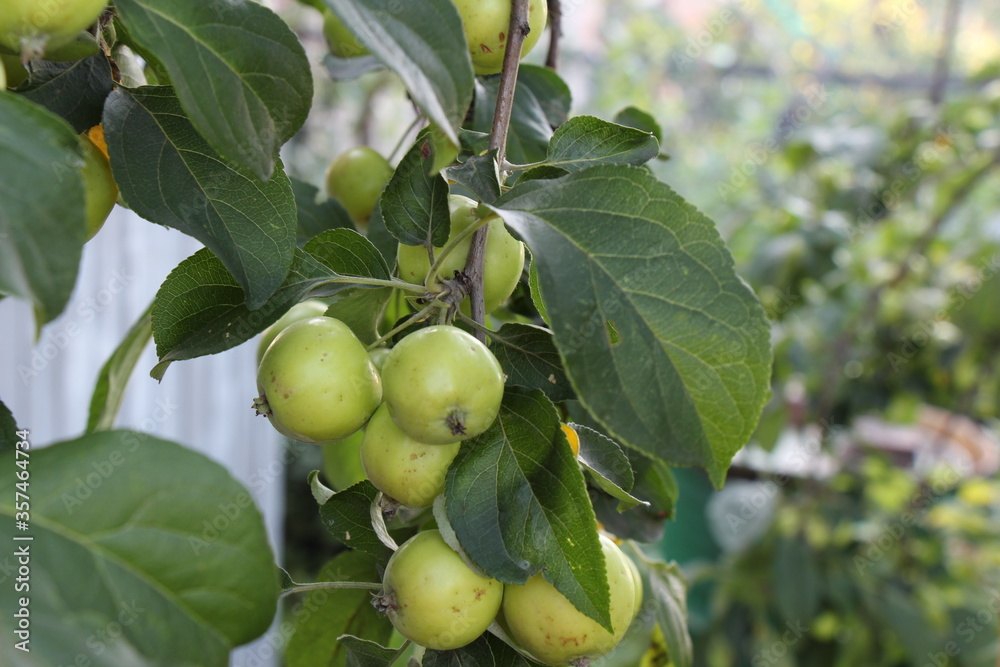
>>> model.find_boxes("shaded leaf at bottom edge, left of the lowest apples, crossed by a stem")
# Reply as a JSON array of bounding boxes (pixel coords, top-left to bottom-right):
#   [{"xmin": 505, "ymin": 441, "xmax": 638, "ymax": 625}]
[{"xmin": 285, "ymin": 551, "xmax": 392, "ymax": 667}]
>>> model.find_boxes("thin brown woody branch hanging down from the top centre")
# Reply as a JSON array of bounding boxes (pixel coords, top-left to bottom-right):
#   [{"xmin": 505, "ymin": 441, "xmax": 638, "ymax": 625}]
[{"xmin": 465, "ymin": 0, "xmax": 531, "ymax": 343}]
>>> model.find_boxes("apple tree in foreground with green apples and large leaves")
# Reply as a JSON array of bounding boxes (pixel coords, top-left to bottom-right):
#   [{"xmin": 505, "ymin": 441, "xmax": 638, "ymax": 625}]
[{"xmin": 0, "ymin": 0, "xmax": 771, "ymax": 667}]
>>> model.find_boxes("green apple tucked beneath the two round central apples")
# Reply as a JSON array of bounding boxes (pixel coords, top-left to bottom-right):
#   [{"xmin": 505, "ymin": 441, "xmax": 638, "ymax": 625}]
[{"xmin": 361, "ymin": 403, "xmax": 461, "ymax": 508}]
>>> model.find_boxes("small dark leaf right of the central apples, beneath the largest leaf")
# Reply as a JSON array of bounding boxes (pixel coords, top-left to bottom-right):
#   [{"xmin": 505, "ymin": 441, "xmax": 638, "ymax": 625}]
[{"xmin": 488, "ymin": 323, "xmax": 573, "ymax": 403}]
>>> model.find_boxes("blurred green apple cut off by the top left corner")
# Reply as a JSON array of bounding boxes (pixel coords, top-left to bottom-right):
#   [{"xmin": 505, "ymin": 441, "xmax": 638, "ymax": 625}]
[{"xmin": 0, "ymin": 0, "xmax": 107, "ymax": 58}]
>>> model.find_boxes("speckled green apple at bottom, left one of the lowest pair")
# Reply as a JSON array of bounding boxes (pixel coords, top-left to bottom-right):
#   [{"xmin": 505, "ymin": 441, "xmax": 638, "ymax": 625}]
[{"xmin": 375, "ymin": 530, "xmax": 503, "ymax": 651}]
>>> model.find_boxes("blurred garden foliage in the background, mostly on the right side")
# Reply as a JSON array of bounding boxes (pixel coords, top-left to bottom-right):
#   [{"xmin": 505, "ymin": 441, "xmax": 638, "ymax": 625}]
[{"xmin": 272, "ymin": 0, "xmax": 1000, "ymax": 667}]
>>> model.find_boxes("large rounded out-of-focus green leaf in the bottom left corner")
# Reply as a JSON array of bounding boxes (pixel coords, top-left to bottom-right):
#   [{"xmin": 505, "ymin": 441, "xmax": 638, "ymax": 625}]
[{"xmin": 0, "ymin": 431, "xmax": 278, "ymax": 667}]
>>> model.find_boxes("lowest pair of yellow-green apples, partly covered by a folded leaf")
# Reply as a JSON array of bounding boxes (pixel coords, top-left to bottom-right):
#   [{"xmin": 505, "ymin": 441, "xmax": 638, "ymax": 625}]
[{"xmin": 375, "ymin": 530, "xmax": 642, "ymax": 666}]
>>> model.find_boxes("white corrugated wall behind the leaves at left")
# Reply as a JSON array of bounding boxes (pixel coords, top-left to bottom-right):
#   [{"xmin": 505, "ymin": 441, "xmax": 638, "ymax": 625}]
[{"xmin": 0, "ymin": 207, "xmax": 284, "ymax": 667}]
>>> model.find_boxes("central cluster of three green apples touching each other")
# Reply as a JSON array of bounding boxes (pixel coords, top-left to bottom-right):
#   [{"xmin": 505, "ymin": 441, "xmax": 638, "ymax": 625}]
[{"xmin": 254, "ymin": 310, "xmax": 504, "ymax": 508}]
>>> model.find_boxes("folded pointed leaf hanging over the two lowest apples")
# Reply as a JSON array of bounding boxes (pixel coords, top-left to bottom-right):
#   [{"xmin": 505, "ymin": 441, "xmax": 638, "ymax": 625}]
[{"xmin": 445, "ymin": 389, "xmax": 611, "ymax": 627}]
